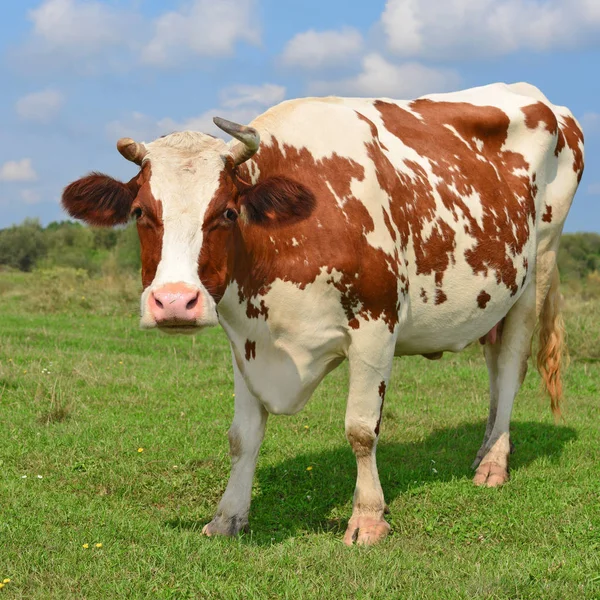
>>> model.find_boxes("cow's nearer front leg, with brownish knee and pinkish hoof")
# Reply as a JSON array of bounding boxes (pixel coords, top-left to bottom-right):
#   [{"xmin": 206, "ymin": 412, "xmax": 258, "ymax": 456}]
[{"xmin": 344, "ymin": 337, "xmax": 393, "ymax": 545}]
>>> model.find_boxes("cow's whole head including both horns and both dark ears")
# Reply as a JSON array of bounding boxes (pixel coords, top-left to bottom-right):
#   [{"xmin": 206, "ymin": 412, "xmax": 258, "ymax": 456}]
[{"xmin": 62, "ymin": 118, "xmax": 314, "ymax": 332}]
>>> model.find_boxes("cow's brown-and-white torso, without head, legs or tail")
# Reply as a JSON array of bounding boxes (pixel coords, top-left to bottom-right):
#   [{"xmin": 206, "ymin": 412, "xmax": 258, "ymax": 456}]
[{"xmin": 219, "ymin": 85, "xmax": 578, "ymax": 413}]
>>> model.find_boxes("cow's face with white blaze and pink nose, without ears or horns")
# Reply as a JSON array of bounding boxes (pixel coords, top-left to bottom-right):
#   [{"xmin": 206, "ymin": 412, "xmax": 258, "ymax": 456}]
[{"xmin": 135, "ymin": 133, "xmax": 238, "ymax": 331}]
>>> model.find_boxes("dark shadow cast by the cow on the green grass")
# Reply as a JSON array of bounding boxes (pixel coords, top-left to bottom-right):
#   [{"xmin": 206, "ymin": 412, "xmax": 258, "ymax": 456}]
[{"xmin": 166, "ymin": 421, "xmax": 577, "ymax": 545}]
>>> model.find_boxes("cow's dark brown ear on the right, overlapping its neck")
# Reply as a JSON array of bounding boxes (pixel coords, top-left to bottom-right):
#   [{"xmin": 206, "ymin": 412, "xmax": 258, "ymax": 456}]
[{"xmin": 240, "ymin": 176, "xmax": 315, "ymax": 227}]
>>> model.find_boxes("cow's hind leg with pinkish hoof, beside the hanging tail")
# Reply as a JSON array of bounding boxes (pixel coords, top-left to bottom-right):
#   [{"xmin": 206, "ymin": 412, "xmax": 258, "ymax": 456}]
[{"xmin": 473, "ymin": 282, "xmax": 536, "ymax": 487}]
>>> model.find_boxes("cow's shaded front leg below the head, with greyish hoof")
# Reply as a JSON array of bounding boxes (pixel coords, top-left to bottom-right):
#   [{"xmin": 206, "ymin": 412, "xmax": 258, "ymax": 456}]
[{"xmin": 202, "ymin": 360, "xmax": 268, "ymax": 536}]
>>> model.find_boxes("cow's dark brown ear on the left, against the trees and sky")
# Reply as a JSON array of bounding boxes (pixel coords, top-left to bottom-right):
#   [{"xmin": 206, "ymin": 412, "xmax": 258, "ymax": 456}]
[{"xmin": 62, "ymin": 173, "xmax": 138, "ymax": 227}]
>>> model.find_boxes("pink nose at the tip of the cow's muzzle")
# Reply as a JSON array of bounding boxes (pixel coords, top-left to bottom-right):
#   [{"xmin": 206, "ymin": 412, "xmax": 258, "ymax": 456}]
[{"xmin": 148, "ymin": 283, "xmax": 202, "ymax": 325}]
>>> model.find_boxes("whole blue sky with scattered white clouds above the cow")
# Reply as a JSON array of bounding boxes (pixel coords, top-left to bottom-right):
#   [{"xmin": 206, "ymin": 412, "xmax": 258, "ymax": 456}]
[{"xmin": 0, "ymin": 0, "xmax": 600, "ymax": 231}]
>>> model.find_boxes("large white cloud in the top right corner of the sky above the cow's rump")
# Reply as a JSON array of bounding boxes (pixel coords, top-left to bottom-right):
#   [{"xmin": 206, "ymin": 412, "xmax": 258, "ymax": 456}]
[{"xmin": 381, "ymin": 0, "xmax": 600, "ymax": 60}]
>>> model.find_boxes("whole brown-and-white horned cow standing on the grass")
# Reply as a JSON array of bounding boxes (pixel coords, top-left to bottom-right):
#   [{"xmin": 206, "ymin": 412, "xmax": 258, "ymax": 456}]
[{"xmin": 62, "ymin": 83, "xmax": 584, "ymax": 545}]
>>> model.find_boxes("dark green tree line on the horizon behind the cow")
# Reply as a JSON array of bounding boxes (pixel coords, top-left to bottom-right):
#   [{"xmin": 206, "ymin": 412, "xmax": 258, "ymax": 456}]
[{"xmin": 0, "ymin": 219, "xmax": 600, "ymax": 281}]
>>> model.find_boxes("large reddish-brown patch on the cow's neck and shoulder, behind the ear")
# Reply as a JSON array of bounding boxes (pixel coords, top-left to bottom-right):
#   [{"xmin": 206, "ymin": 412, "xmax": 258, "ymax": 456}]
[{"xmin": 212, "ymin": 138, "xmax": 399, "ymax": 331}]
